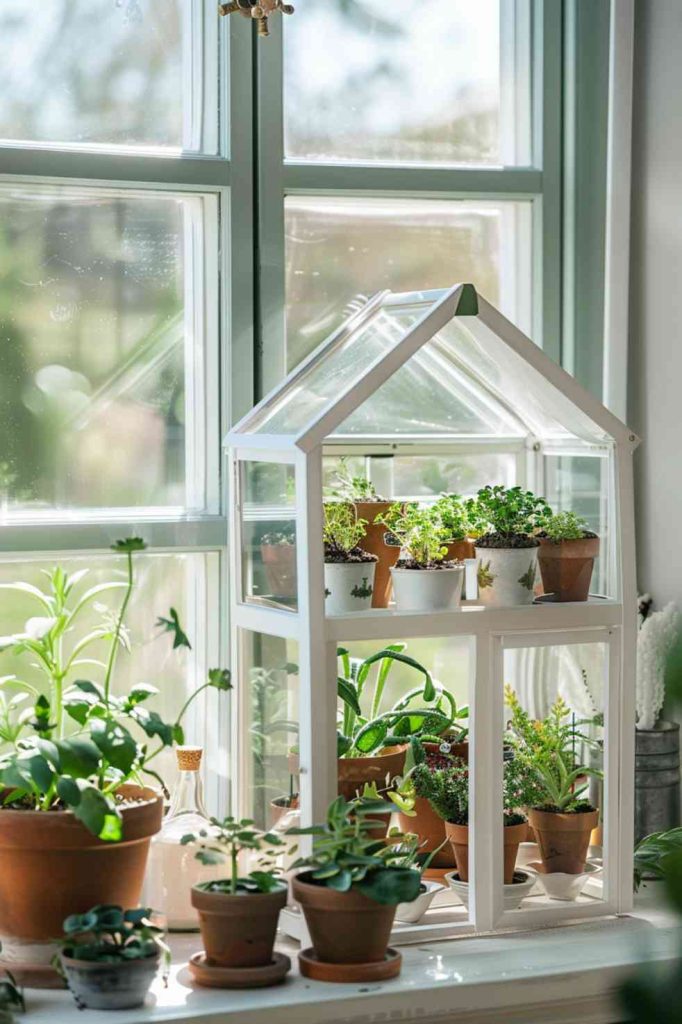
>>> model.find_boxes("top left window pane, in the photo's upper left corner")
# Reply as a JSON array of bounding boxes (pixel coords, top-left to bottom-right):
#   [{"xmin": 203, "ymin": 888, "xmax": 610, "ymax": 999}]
[{"xmin": 0, "ymin": 0, "xmax": 217, "ymax": 153}]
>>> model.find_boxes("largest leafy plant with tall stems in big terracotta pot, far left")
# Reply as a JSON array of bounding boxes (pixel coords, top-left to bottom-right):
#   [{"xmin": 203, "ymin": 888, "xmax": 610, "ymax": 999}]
[{"xmin": 0, "ymin": 538, "xmax": 230, "ymax": 972}]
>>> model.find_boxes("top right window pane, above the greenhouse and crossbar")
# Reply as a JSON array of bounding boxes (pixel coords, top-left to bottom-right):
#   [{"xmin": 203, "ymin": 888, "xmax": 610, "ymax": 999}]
[{"xmin": 285, "ymin": 0, "xmax": 529, "ymax": 165}]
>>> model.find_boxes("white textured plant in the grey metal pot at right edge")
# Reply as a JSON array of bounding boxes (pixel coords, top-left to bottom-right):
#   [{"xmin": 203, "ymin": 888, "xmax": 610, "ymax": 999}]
[{"xmin": 637, "ymin": 601, "xmax": 680, "ymax": 729}]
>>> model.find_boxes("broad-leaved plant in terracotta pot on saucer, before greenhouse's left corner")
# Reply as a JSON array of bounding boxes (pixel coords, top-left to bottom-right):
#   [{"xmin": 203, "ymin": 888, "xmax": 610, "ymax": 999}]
[{"xmin": 288, "ymin": 797, "xmax": 421, "ymax": 981}]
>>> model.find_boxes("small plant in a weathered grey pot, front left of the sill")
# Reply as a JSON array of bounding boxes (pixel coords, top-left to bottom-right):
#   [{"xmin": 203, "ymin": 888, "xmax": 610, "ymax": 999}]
[{"xmin": 59, "ymin": 905, "xmax": 170, "ymax": 1010}]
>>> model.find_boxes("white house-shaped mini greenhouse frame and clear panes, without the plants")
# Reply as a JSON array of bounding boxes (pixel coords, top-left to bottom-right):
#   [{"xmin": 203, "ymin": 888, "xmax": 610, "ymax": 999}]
[{"xmin": 226, "ymin": 285, "xmax": 638, "ymax": 941}]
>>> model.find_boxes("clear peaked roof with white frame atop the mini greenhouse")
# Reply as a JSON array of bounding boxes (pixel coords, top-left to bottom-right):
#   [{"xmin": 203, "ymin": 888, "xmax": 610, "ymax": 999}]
[{"xmin": 226, "ymin": 284, "xmax": 636, "ymax": 452}]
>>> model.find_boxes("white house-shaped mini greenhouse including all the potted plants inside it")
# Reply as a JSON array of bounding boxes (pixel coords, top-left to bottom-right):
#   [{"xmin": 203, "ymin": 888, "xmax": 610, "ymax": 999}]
[{"xmin": 225, "ymin": 284, "xmax": 639, "ymax": 942}]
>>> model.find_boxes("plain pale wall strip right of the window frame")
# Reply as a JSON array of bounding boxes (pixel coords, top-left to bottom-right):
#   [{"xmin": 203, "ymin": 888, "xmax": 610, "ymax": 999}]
[{"xmin": 628, "ymin": 0, "xmax": 682, "ymax": 607}]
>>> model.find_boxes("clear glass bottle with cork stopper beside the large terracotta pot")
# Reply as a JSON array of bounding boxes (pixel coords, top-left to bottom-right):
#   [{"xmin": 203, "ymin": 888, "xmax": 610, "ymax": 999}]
[{"xmin": 144, "ymin": 746, "xmax": 225, "ymax": 932}]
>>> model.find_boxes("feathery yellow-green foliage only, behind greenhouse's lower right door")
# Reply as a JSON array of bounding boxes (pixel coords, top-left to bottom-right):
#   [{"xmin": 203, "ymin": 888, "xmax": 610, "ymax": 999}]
[{"xmin": 505, "ymin": 685, "xmax": 602, "ymax": 812}]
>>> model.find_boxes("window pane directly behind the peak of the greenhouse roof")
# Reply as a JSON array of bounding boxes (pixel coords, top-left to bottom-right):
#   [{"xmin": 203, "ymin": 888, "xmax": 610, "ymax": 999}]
[{"xmin": 286, "ymin": 197, "xmax": 531, "ymax": 368}]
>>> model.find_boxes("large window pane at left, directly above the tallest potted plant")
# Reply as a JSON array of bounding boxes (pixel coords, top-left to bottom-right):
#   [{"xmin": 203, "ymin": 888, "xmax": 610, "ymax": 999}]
[{"xmin": 0, "ymin": 186, "xmax": 215, "ymax": 513}]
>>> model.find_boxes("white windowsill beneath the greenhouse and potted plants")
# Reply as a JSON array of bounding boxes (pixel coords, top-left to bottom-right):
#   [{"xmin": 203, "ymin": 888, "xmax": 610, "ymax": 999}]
[{"xmin": 19, "ymin": 885, "xmax": 678, "ymax": 1024}]
